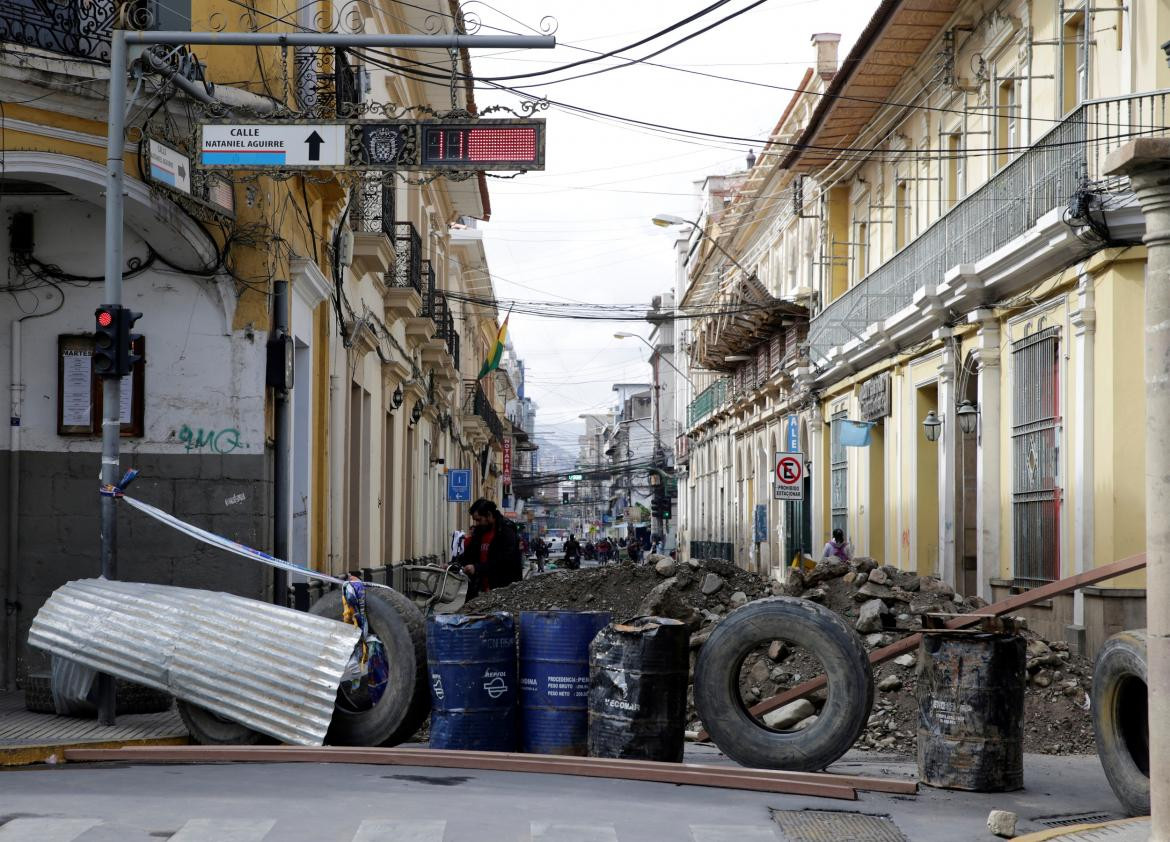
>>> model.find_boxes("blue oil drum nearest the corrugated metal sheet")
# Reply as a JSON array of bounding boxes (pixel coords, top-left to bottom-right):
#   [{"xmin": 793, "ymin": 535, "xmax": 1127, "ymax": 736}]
[{"xmin": 427, "ymin": 612, "xmax": 517, "ymax": 751}]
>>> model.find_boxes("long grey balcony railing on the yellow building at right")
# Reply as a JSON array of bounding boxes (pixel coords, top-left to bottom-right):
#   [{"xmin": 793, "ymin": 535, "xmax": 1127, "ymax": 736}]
[{"xmin": 808, "ymin": 91, "xmax": 1170, "ymax": 358}]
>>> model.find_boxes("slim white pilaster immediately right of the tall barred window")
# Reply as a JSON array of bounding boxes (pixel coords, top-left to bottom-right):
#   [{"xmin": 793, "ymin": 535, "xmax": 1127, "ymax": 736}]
[{"xmin": 1067, "ymin": 264, "xmax": 1096, "ymax": 655}]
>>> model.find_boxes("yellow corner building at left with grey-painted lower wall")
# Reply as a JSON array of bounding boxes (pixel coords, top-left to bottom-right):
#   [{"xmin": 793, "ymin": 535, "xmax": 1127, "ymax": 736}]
[{"xmin": 0, "ymin": 0, "xmax": 512, "ymax": 685}]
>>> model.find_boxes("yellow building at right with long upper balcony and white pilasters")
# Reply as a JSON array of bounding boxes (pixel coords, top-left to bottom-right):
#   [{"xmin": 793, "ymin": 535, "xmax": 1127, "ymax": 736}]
[{"xmin": 691, "ymin": 0, "xmax": 1170, "ymax": 653}]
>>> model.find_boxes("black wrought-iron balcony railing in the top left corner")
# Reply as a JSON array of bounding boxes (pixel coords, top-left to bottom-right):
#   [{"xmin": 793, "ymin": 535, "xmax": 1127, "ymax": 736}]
[{"xmin": 0, "ymin": 0, "xmax": 115, "ymax": 62}]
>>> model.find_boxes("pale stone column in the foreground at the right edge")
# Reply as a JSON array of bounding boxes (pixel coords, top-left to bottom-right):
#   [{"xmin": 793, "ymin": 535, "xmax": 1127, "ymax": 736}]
[{"xmin": 1104, "ymin": 138, "xmax": 1170, "ymax": 842}]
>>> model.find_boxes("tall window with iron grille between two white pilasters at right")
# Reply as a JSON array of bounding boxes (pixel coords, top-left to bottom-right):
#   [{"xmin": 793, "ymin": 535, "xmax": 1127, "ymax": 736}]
[{"xmin": 1012, "ymin": 327, "xmax": 1061, "ymax": 587}]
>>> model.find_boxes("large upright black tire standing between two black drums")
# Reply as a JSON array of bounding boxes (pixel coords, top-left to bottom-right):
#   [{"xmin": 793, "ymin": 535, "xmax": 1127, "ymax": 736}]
[{"xmin": 695, "ymin": 596, "xmax": 874, "ymax": 772}]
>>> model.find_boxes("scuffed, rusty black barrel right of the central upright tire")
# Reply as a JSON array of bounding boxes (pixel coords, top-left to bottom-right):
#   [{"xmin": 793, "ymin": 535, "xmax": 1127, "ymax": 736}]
[{"xmin": 917, "ymin": 632, "xmax": 1026, "ymax": 792}]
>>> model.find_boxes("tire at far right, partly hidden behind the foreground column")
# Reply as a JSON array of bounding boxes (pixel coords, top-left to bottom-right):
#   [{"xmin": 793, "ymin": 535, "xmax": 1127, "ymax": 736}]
[{"xmin": 1092, "ymin": 629, "xmax": 1150, "ymax": 816}]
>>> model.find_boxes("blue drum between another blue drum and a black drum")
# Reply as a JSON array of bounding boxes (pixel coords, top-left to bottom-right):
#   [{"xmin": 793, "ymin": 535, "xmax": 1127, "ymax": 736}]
[{"xmin": 519, "ymin": 612, "xmax": 611, "ymax": 757}]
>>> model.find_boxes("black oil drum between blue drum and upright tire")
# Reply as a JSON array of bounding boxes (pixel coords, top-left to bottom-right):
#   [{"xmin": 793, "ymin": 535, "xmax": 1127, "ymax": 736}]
[{"xmin": 589, "ymin": 616, "xmax": 690, "ymax": 762}]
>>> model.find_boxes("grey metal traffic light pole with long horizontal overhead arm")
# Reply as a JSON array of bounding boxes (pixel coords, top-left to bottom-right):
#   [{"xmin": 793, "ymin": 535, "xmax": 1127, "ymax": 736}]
[{"xmin": 98, "ymin": 29, "xmax": 557, "ymax": 725}]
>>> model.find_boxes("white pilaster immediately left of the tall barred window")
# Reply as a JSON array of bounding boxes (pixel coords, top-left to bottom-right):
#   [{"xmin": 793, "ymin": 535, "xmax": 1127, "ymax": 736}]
[{"xmin": 968, "ymin": 310, "xmax": 1004, "ymax": 602}]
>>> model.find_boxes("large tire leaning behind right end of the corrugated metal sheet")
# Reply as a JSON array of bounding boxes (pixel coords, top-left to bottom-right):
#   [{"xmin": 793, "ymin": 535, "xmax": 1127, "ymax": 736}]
[{"xmin": 309, "ymin": 588, "xmax": 426, "ymax": 746}]
